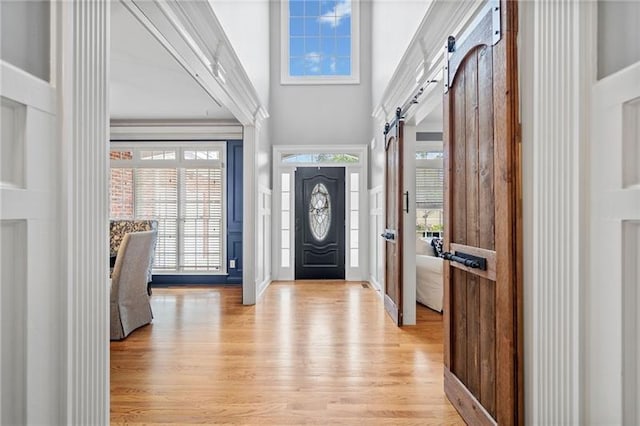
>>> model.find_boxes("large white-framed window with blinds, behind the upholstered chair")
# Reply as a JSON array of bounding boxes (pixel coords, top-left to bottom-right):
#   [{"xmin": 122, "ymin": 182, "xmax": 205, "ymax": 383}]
[{"xmin": 111, "ymin": 144, "xmax": 226, "ymax": 273}]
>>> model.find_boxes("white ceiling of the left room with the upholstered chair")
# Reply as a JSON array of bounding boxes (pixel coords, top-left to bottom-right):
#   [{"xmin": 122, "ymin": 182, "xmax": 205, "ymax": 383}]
[{"xmin": 110, "ymin": 1, "xmax": 234, "ymax": 120}]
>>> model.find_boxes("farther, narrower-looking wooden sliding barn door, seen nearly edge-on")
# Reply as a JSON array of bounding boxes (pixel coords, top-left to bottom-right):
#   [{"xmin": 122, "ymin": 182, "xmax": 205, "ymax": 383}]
[{"xmin": 382, "ymin": 117, "xmax": 404, "ymax": 325}]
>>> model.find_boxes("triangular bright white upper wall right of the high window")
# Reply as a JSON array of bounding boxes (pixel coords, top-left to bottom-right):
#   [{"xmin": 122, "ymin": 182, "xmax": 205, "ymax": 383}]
[{"xmin": 371, "ymin": 0, "xmax": 431, "ymax": 110}]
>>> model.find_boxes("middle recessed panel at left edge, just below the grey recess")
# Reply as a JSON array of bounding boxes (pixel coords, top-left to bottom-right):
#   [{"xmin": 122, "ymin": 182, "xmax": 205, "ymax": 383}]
[{"xmin": 0, "ymin": 97, "xmax": 26, "ymax": 188}]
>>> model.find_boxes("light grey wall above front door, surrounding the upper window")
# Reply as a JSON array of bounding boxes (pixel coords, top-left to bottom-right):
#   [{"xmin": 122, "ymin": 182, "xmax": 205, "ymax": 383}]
[{"xmin": 269, "ymin": 1, "xmax": 372, "ymax": 145}]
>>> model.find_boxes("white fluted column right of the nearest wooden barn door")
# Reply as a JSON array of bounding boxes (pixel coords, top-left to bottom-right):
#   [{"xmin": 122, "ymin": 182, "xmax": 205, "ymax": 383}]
[{"xmin": 519, "ymin": 0, "xmax": 593, "ymax": 425}]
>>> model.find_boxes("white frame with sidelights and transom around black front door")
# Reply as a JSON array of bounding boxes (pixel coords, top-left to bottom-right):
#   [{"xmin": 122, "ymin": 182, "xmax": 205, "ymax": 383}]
[{"xmin": 271, "ymin": 145, "xmax": 369, "ymax": 281}]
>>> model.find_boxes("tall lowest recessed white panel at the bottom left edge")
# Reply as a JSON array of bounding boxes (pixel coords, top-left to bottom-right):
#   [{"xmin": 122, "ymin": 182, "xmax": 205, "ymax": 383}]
[{"xmin": 0, "ymin": 220, "xmax": 27, "ymax": 425}]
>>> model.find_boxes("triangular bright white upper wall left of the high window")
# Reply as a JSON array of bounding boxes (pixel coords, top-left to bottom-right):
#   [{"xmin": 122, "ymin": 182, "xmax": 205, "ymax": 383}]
[{"xmin": 210, "ymin": 0, "xmax": 270, "ymax": 108}]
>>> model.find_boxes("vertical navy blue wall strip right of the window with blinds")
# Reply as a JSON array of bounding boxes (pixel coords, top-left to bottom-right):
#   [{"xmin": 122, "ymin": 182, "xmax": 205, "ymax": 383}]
[{"xmin": 227, "ymin": 141, "xmax": 242, "ymax": 284}]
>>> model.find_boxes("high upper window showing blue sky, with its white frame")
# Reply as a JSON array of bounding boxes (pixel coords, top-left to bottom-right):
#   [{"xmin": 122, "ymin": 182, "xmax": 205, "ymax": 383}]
[{"xmin": 281, "ymin": 0, "xmax": 360, "ymax": 84}]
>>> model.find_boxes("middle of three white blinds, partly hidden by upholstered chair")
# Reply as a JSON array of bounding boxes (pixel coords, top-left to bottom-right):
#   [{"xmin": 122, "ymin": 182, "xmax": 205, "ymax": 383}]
[{"xmin": 134, "ymin": 168, "xmax": 178, "ymax": 271}]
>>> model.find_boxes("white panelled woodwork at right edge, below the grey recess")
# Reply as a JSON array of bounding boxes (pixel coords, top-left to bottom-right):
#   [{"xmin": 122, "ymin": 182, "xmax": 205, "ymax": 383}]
[{"xmin": 585, "ymin": 59, "xmax": 640, "ymax": 424}]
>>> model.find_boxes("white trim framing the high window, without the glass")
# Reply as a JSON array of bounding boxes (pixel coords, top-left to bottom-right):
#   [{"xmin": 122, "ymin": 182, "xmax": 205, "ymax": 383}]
[{"xmin": 280, "ymin": 0, "xmax": 360, "ymax": 85}]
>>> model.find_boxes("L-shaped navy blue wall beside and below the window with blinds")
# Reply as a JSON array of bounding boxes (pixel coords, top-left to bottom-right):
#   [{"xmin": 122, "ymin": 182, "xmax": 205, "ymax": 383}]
[{"xmin": 152, "ymin": 141, "xmax": 242, "ymax": 287}]
